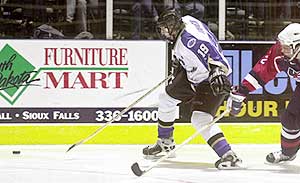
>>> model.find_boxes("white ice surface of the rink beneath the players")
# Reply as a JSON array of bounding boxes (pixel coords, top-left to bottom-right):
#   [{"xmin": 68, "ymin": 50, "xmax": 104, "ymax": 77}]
[{"xmin": 0, "ymin": 145, "xmax": 300, "ymax": 183}]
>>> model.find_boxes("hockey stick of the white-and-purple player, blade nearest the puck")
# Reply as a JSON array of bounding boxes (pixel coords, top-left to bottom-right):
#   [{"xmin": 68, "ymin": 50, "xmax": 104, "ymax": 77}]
[{"xmin": 66, "ymin": 74, "xmax": 173, "ymax": 152}]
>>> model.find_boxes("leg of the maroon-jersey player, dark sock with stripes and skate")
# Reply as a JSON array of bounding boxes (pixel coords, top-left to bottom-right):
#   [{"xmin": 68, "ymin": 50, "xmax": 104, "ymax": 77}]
[{"xmin": 266, "ymin": 85, "xmax": 300, "ymax": 163}]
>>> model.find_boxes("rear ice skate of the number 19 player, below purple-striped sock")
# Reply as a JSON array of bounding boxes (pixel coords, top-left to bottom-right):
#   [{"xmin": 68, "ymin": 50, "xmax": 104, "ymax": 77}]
[{"xmin": 215, "ymin": 150, "xmax": 245, "ymax": 170}]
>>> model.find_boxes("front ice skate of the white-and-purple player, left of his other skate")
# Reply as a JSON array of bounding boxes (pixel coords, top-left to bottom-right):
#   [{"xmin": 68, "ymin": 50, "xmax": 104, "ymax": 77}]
[{"xmin": 143, "ymin": 137, "xmax": 175, "ymax": 159}]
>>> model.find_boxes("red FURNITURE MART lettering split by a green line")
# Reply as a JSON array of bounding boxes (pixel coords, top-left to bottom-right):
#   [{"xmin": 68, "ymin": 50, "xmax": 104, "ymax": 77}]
[{"xmin": 43, "ymin": 48, "xmax": 128, "ymax": 89}]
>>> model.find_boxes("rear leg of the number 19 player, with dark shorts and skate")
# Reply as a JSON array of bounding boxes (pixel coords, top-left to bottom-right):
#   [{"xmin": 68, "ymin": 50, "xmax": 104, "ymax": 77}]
[{"xmin": 191, "ymin": 83, "xmax": 242, "ymax": 169}]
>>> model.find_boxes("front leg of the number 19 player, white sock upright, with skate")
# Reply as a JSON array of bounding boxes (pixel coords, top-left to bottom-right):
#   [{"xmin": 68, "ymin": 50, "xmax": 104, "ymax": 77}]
[{"xmin": 143, "ymin": 68, "xmax": 195, "ymax": 157}]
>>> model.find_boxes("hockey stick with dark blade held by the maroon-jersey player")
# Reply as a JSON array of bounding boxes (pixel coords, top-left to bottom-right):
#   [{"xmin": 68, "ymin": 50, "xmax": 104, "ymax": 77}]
[{"xmin": 131, "ymin": 108, "xmax": 230, "ymax": 177}]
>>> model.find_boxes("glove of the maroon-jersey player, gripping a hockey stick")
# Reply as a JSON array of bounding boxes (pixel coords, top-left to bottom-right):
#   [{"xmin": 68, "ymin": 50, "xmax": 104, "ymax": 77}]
[{"xmin": 227, "ymin": 86, "xmax": 246, "ymax": 116}]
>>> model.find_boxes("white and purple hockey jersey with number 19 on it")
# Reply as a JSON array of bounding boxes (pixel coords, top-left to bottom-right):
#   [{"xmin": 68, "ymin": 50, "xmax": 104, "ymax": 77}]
[{"xmin": 173, "ymin": 15, "xmax": 232, "ymax": 84}]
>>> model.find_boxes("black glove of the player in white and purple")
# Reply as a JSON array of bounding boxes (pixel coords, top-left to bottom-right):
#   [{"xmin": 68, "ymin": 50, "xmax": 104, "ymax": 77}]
[{"xmin": 208, "ymin": 67, "xmax": 231, "ymax": 96}]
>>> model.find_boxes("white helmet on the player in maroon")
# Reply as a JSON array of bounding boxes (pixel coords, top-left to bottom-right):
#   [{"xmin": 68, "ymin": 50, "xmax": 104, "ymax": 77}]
[{"xmin": 278, "ymin": 23, "xmax": 300, "ymax": 49}]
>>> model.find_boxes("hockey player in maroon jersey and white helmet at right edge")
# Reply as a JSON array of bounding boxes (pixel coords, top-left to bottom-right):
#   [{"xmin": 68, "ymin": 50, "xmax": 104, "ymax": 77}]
[{"xmin": 227, "ymin": 23, "xmax": 300, "ymax": 164}]
